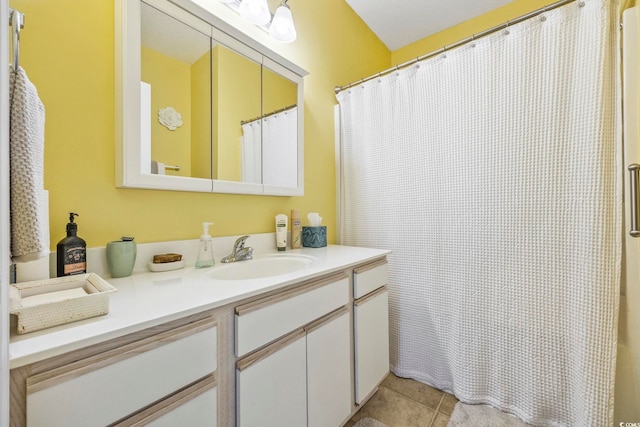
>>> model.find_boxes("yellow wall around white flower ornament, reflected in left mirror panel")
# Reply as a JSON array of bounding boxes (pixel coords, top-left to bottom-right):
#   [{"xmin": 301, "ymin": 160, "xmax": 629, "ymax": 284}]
[{"xmin": 140, "ymin": 47, "xmax": 191, "ymax": 176}]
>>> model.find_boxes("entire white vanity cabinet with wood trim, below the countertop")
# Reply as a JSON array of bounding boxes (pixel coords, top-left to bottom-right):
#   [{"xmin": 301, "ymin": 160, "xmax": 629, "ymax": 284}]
[{"xmin": 10, "ymin": 251, "xmax": 389, "ymax": 427}]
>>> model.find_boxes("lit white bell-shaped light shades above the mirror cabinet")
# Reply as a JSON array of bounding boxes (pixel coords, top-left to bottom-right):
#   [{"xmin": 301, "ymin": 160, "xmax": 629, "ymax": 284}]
[{"xmin": 218, "ymin": 0, "xmax": 297, "ymax": 43}]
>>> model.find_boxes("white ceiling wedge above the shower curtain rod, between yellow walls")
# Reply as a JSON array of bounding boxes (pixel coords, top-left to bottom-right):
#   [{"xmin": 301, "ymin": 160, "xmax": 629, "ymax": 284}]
[{"xmin": 345, "ymin": 0, "xmax": 513, "ymax": 51}]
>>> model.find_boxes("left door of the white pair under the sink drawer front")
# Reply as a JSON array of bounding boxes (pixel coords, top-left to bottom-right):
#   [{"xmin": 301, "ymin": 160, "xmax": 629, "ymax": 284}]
[{"xmin": 236, "ymin": 329, "xmax": 307, "ymax": 427}]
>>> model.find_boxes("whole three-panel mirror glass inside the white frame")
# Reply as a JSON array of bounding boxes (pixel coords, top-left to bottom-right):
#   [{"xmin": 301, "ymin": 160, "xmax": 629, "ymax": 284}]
[{"xmin": 140, "ymin": 2, "xmax": 299, "ymax": 188}]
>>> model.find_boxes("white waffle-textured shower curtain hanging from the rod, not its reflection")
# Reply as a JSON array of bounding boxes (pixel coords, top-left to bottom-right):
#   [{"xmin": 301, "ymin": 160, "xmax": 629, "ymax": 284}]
[{"xmin": 337, "ymin": 0, "xmax": 622, "ymax": 426}]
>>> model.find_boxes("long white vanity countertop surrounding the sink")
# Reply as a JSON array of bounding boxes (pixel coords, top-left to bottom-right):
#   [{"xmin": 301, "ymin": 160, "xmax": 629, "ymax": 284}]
[{"xmin": 9, "ymin": 245, "xmax": 389, "ymax": 368}]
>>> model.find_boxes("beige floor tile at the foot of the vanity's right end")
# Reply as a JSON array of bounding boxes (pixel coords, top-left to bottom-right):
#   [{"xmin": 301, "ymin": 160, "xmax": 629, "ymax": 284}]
[{"xmin": 352, "ymin": 387, "xmax": 435, "ymax": 427}]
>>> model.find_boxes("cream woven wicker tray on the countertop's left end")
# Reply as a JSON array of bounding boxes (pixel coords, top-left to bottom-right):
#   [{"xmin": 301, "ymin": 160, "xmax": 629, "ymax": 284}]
[{"xmin": 9, "ymin": 273, "xmax": 117, "ymax": 334}]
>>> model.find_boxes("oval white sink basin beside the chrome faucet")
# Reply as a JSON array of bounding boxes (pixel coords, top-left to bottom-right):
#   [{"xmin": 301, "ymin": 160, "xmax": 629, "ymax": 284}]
[{"xmin": 209, "ymin": 254, "xmax": 315, "ymax": 280}]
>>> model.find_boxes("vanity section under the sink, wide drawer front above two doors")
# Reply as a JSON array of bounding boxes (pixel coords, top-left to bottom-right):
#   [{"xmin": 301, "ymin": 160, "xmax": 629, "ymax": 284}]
[{"xmin": 236, "ymin": 273, "xmax": 352, "ymax": 427}]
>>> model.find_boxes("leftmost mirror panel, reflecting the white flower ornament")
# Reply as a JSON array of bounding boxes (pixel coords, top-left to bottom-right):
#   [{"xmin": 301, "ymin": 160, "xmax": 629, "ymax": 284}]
[{"xmin": 140, "ymin": 3, "xmax": 212, "ymax": 179}]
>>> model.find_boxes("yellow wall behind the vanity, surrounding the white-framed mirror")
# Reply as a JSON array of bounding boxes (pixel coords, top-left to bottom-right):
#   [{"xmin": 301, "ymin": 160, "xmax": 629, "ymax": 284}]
[{"xmin": 10, "ymin": 0, "xmax": 391, "ymax": 248}]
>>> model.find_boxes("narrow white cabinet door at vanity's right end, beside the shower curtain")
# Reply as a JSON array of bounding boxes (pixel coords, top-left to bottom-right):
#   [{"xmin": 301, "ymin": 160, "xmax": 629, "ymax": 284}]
[{"xmin": 354, "ymin": 287, "xmax": 389, "ymax": 404}]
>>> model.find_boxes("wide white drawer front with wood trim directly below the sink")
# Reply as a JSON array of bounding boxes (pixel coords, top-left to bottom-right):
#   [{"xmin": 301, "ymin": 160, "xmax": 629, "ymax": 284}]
[{"xmin": 235, "ymin": 273, "xmax": 349, "ymax": 357}]
